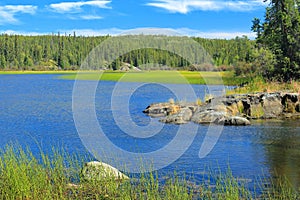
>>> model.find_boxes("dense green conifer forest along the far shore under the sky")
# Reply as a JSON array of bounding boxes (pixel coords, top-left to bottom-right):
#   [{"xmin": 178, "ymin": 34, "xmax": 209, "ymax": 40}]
[{"xmin": 0, "ymin": 33, "xmax": 255, "ymax": 70}]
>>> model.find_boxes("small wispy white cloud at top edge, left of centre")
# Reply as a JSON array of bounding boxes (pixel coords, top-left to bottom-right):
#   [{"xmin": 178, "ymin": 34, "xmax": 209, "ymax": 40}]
[{"xmin": 49, "ymin": 0, "xmax": 111, "ymax": 13}]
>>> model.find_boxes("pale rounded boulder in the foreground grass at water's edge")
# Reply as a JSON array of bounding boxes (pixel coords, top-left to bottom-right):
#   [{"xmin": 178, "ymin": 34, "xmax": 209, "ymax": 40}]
[{"xmin": 81, "ymin": 161, "xmax": 129, "ymax": 181}]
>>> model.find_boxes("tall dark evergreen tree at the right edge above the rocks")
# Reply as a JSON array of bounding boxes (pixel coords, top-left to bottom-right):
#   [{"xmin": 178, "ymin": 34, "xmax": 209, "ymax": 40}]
[{"xmin": 252, "ymin": 0, "xmax": 300, "ymax": 81}]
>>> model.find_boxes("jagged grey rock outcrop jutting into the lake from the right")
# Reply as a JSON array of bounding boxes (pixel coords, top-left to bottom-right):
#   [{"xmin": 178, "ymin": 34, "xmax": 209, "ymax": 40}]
[{"xmin": 143, "ymin": 92, "xmax": 300, "ymax": 126}]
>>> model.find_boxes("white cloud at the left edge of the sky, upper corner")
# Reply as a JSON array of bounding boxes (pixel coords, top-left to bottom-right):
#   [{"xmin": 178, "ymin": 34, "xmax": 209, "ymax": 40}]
[{"xmin": 0, "ymin": 5, "xmax": 37, "ymax": 24}]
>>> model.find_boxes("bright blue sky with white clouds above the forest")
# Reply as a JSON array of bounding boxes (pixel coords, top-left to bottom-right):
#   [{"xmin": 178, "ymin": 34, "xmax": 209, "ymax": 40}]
[{"xmin": 0, "ymin": 0, "xmax": 267, "ymax": 38}]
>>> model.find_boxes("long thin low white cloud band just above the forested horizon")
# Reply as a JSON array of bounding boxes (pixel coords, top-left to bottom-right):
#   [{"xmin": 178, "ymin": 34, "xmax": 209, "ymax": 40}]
[{"xmin": 0, "ymin": 28, "xmax": 256, "ymax": 39}]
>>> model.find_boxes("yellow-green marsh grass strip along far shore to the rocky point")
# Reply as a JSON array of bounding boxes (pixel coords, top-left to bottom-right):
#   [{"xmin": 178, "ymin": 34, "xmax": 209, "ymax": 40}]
[{"xmin": 0, "ymin": 70, "xmax": 300, "ymax": 95}]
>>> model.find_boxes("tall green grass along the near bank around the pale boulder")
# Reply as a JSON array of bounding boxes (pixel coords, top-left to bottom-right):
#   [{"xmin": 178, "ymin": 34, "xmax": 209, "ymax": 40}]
[{"xmin": 0, "ymin": 146, "xmax": 299, "ymax": 199}]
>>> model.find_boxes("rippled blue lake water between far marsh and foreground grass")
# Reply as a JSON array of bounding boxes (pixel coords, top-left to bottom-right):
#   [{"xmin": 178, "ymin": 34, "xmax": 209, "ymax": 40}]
[{"xmin": 0, "ymin": 75, "xmax": 300, "ymax": 192}]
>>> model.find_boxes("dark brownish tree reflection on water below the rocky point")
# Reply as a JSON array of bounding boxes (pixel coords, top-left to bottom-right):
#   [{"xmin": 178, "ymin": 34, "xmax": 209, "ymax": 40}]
[{"xmin": 255, "ymin": 120, "xmax": 300, "ymax": 188}]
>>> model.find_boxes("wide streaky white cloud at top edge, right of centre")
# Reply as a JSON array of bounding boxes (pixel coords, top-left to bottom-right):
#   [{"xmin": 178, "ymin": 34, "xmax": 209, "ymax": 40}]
[{"xmin": 146, "ymin": 0, "xmax": 268, "ymax": 14}]
